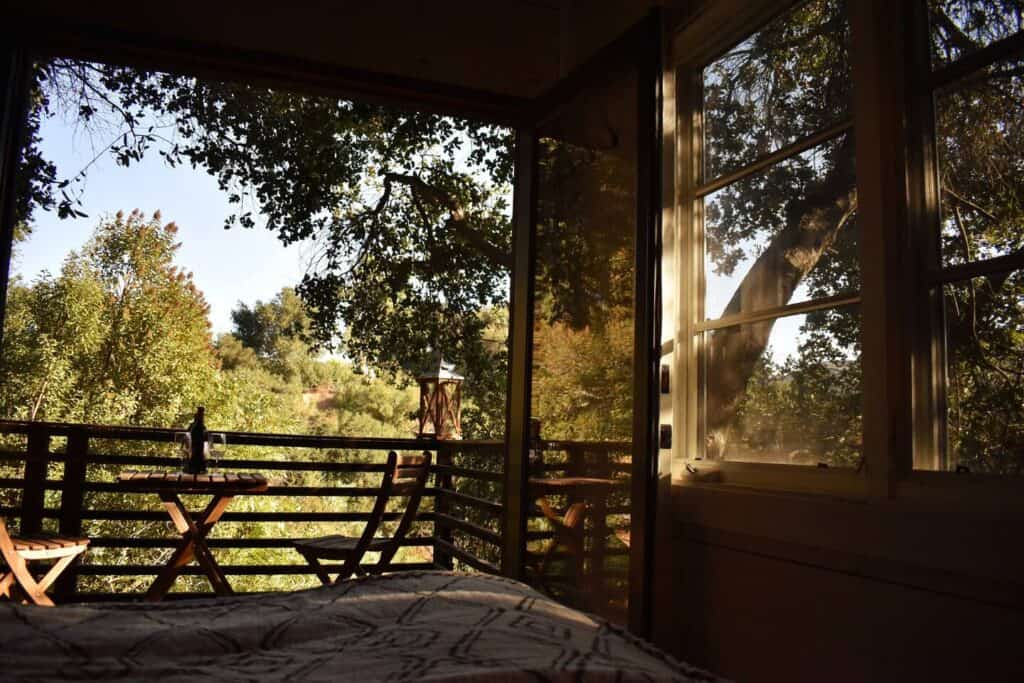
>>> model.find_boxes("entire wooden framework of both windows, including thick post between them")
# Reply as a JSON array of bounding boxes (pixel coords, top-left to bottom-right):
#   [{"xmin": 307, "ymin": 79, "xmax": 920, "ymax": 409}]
[{"xmin": 666, "ymin": 0, "xmax": 1024, "ymax": 511}]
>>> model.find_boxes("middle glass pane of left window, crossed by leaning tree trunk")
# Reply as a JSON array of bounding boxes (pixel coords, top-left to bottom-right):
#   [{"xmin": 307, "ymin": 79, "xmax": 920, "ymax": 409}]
[{"xmin": 705, "ymin": 135, "xmax": 860, "ymax": 318}]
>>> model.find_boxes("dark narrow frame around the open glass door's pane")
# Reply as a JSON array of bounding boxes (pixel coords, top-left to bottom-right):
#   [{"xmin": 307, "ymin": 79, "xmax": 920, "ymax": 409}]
[{"xmin": 502, "ymin": 11, "xmax": 662, "ymax": 636}]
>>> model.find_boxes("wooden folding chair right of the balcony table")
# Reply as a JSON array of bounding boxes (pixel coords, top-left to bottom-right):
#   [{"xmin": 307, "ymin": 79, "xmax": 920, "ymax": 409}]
[{"xmin": 293, "ymin": 451, "xmax": 430, "ymax": 586}]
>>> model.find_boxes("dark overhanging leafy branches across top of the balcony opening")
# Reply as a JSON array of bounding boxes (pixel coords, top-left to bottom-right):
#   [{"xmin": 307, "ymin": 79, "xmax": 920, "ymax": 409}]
[{"xmin": 28, "ymin": 59, "xmax": 512, "ymax": 397}]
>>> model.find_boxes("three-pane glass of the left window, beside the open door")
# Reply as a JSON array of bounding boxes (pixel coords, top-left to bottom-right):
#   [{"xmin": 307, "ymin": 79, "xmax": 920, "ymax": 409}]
[{"xmin": 687, "ymin": 0, "xmax": 861, "ymax": 467}]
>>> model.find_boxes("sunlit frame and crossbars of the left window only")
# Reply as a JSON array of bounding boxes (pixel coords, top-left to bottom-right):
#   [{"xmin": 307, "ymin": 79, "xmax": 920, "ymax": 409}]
[{"xmin": 674, "ymin": 0, "xmax": 867, "ymax": 493}]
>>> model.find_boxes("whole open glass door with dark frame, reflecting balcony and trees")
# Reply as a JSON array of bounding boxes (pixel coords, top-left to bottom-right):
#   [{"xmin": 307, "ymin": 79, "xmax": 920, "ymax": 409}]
[{"xmin": 505, "ymin": 16, "xmax": 660, "ymax": 633}]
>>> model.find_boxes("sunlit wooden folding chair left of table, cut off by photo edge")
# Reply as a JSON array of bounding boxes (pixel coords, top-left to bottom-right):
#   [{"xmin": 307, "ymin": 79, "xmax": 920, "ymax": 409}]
[{"xmin": 0, "ymin": 517, "xmax": 89, "ymax": 607}]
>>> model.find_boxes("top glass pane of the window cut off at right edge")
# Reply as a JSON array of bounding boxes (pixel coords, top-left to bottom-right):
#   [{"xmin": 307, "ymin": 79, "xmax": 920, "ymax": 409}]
[{"xmin": 928, "ymin": 0, "xmax": 1024, "ymax": 68}]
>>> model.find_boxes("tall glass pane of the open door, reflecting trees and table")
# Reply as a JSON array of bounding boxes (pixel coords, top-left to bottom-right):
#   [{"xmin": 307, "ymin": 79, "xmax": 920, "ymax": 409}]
[{"xmin": 527, "ymin": 65, "xmax": 637, "ymax": 622}]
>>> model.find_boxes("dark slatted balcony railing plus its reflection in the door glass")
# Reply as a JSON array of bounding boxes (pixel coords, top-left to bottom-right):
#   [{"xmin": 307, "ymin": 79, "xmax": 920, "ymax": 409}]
[{"xmin": 0, "ymin": 421, "xmax": 630, "ymax": 621}]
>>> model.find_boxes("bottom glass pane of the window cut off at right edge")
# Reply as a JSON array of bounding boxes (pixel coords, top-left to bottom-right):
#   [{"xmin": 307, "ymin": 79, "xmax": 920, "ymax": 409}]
[{"xmin": 936, "ymin": 271, "xmax": 1024, "ymax": 474}]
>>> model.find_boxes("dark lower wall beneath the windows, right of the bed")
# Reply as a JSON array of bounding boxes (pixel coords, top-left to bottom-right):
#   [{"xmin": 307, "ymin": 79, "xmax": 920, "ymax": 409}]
[{"xmin": 654, "ymin": 482, "xmax": 1024, "ymax": 681}]
